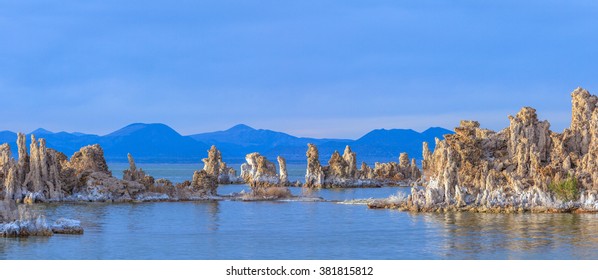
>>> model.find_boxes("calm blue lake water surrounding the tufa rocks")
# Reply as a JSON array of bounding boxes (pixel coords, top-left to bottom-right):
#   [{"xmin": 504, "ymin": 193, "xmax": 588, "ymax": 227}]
[{"xmin": 0, "ymin": 164, "xmax": 598, "ymax": 260}]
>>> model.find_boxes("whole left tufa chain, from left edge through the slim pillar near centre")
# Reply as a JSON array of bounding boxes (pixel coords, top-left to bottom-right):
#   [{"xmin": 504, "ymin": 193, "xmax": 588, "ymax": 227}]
[{"xmin": 0, "ymin": 133, "xmax": 224, "ymax": 203}]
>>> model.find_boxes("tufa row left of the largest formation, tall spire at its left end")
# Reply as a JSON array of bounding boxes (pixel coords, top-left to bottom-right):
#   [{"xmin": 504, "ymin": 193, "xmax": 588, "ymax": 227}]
[{"xmin": 304, "ymin": 144, "xmax": 421, "ymax": 188}]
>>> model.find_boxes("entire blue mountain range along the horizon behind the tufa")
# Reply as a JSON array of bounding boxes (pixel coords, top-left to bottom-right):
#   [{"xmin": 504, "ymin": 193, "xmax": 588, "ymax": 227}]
[{"xmin": 0, "ymin": 123, "xmax": 453, "ymax": 164}]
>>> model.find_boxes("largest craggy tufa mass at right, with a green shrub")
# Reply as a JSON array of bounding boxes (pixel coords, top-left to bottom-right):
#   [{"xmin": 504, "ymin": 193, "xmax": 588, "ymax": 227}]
[{"xmin": 371, "ymin": 88, "xmax": 598, "ymax": 212}]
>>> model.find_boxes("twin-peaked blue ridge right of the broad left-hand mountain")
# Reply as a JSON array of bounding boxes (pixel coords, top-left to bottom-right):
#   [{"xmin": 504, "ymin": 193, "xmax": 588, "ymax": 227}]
[{"xmin": 191, "ymin": 124, "xmax": 453, "ymax": 163}]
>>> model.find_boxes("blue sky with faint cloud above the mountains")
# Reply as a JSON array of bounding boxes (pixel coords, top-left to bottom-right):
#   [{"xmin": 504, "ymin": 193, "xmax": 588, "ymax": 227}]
[{"xmin": 0, "ymin": 0, "xmax": 598, "ymax": 138}]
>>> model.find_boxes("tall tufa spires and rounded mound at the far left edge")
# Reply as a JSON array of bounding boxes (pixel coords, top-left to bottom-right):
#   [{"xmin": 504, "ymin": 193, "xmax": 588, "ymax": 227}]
[{"xmin": 0, "ymin": 133, "xmax": 116, "ymax": 203}]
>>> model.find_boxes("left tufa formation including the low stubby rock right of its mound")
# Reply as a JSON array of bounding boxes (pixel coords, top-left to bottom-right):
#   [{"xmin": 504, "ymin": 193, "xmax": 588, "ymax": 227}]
[{"xmin": 0, "ymin": 133, "xmax": 157, "ymax": 203}]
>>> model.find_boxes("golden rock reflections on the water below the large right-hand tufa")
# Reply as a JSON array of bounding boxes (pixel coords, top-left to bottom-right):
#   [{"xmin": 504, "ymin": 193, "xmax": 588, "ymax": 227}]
[{"xmin": 422, "ymin": 213, "xmax": 598, "ymax": 259}]
